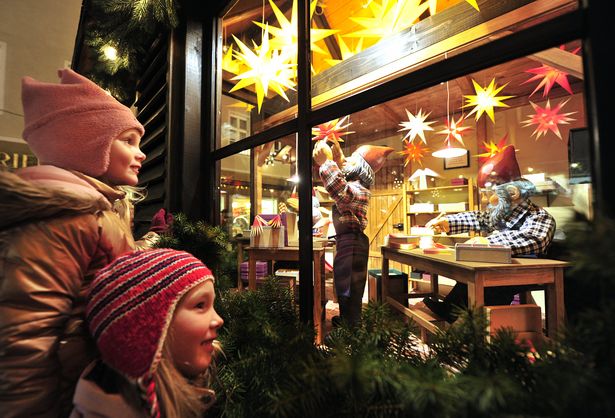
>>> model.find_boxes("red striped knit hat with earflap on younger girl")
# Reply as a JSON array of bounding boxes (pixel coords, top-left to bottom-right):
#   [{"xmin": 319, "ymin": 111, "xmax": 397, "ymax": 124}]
[{"xmin": 86, "ymin": 248, "xmax": 214, "ymax": 416}]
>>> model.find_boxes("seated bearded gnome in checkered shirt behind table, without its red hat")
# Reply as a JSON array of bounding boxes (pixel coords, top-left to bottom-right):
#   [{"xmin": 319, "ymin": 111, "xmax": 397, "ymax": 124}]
[{"xmin": 423, "ymin": 178, "xmax": 555, "ymax": 322}]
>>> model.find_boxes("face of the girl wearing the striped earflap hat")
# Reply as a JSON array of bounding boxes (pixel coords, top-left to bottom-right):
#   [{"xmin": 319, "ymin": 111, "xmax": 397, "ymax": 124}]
[{"xmin": 169, "ymin": 280, "xmax": 224, "ymax": 377}]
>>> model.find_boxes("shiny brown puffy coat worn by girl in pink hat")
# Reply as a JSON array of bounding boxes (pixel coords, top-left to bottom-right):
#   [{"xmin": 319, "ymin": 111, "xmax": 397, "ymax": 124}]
[{"xmin": 0, "ymin": 166, "xmax": 135, "ymax": 418}]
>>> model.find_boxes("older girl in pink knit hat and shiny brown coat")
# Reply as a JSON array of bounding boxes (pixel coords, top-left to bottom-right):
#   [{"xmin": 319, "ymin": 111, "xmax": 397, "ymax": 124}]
[{"xmin": 0, "ymin": 69, "xmax": 153, "ymax": 418}]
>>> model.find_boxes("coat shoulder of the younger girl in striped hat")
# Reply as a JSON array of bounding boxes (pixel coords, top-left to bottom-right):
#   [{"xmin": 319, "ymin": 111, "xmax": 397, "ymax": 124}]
[{"xmin": 70, "ymin": 362, "xmax": 147, "ymax": 418}]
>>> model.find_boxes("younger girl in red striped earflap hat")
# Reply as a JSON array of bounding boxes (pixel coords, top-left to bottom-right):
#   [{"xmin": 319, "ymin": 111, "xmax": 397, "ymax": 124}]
[{"xmin": 71, "ymin": 249, "xmax": 223, "ymax": 418}]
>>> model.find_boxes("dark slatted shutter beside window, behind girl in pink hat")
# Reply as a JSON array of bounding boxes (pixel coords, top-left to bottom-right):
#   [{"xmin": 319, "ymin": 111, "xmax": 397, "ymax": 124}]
[{"xmin": 134, "ymin": 35, "xmax": 169, "ymax": 237}]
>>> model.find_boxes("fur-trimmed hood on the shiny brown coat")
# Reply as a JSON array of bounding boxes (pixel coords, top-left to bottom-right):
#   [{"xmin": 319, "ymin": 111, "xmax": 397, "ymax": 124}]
[{"xmin": 0, "ymin": 165, "xmax": 125, "ymax": 230}]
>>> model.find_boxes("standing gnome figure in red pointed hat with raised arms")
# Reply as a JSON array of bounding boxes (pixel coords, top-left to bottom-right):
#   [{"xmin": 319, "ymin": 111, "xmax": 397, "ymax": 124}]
[{"xmin": 313, "ymin": 141, "xmax": 393, "ymax": 326}]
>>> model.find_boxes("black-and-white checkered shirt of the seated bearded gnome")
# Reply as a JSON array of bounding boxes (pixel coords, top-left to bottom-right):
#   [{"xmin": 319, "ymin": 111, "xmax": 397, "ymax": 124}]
[{"xmin": 446, "ymin": 200, "xmax": 555, "ymax": 255}]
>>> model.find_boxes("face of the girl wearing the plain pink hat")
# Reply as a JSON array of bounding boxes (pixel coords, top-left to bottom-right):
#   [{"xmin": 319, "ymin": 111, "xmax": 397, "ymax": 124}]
[{"xmin": 101, "ymin": 129, "xmax": 145, "ymax": 186}]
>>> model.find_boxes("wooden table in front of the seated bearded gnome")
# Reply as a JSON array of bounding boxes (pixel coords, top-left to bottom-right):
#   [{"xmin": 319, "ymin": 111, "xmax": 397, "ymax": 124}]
[{"xmin": 381, "ymin": 246, "xmax": 569, "ymax": 336}]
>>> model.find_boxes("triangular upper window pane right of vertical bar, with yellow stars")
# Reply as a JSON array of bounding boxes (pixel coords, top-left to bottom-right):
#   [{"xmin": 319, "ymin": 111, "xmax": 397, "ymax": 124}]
[{"xmin": 311, "ymin": 0, "xmax": 578, "ymax": 107}]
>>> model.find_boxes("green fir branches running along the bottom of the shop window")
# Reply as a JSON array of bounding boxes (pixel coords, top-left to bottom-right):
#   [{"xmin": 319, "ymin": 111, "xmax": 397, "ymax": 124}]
[{"xmin": 153, "ymin": 214, "xmax": 615, "ymax": 418}]
